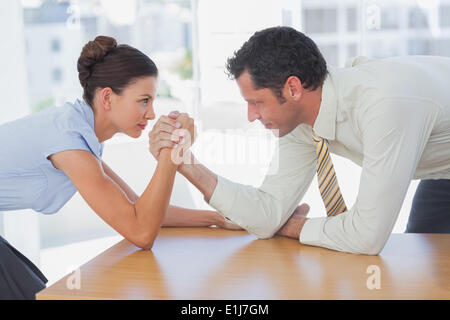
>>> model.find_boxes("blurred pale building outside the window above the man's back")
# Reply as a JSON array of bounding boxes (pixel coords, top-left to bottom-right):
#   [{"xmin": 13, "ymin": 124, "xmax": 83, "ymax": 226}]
[{"xmin": 301, "ymin": 0, "xmax": 450, "ymax": 66}]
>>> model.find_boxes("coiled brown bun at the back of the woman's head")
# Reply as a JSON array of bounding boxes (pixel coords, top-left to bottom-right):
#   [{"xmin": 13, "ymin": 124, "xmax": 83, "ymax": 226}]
[{"xmin": 77, "ymin": 36, "xmax": 117, "ymax": 88}]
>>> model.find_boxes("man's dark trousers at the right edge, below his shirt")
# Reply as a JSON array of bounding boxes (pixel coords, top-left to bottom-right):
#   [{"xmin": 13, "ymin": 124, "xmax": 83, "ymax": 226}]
[{"xmin": 405, "ymin": 179, "xmax": 450, "ymax": 233}]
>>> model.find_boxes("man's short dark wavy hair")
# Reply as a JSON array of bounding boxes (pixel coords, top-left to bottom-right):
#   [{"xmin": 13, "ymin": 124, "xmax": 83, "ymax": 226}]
[{"xmin": 226, "ymin": 27, "xmax": 328, "ymax": 103}]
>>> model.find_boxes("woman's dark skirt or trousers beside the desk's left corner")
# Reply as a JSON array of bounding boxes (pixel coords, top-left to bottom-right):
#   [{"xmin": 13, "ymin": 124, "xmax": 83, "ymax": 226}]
[{"xmin": 0, "ymin": 236, "xmax": 48, "ymax": 300}]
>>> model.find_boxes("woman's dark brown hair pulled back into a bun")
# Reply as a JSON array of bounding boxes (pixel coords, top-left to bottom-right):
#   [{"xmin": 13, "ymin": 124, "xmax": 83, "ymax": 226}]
[{"xmin": 77, "ymin": 36, "xmax": 158, "ymax": 107}]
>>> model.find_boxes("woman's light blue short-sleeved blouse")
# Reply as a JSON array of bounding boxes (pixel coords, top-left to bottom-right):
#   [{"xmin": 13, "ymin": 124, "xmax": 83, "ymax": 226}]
[{"xmin": 0, "ymin": 100, "xmax": 103, "ymax": 214}]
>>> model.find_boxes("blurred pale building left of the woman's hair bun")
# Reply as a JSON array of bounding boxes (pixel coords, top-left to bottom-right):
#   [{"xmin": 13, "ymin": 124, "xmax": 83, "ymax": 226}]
[{"xmin": 24, "ymin": 2, "xmax": 83, "ymax": 111}]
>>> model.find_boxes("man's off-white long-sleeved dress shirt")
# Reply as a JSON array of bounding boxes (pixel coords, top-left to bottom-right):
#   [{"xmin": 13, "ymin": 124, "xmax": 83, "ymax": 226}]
[{"xmin": 209, "ymin": 56, "xmax": 450, "ymax": 254}]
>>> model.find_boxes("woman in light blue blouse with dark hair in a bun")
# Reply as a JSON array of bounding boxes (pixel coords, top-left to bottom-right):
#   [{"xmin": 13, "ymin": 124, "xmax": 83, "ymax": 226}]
[{"xmin": 0, "ymin": 36, "xmax": 237, "ymax": 299}]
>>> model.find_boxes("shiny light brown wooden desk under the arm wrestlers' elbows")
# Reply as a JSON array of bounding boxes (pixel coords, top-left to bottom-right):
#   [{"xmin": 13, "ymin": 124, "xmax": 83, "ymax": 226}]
[{"xmin": 36, "ymin": 228, "xmax": 450, "ymax": 300}]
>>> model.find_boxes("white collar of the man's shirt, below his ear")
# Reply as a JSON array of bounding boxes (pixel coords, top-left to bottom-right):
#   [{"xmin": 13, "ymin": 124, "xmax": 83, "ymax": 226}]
[{"xmin": 313, "ymin": 68, "xmax": 337, "ymax": 140}]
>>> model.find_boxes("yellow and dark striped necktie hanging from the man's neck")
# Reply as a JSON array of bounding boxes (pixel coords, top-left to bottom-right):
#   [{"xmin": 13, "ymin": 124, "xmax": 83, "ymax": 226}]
[{"xmin": 313, "ymin": 133, "xmax": 347, "ymax": 216}]
